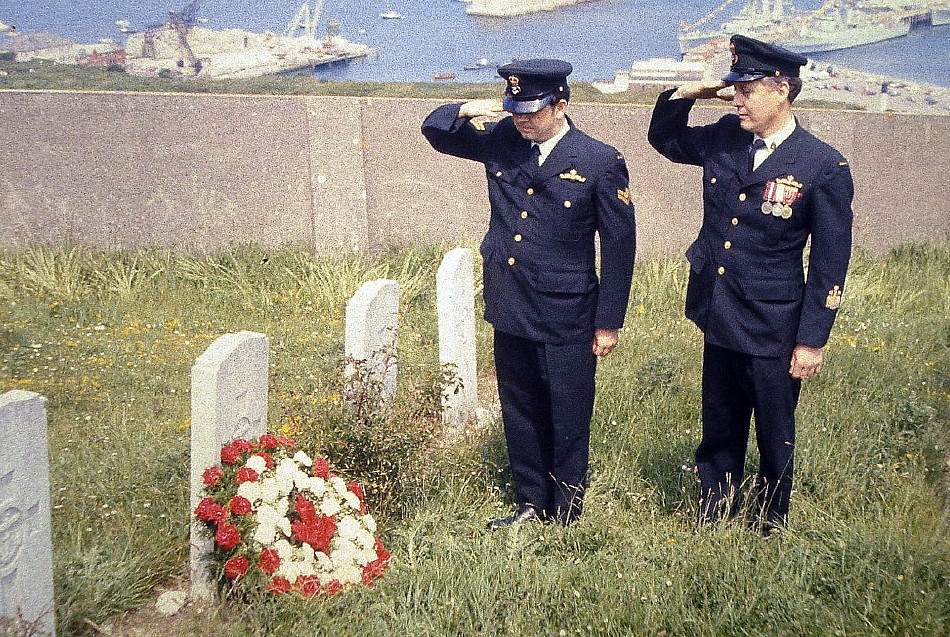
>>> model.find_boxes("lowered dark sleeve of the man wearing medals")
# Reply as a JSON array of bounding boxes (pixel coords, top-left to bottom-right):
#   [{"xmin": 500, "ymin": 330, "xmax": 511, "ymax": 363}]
[{"xmin": 796, "ymin": 155, "xmax": 854, "ymax": 347}]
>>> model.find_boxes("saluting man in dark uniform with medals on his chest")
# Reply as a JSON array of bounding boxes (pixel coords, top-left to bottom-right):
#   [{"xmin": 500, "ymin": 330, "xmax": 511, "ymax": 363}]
[{"xmin": 649, "ymin": 35, "xmax": 854, "ymax": 535}]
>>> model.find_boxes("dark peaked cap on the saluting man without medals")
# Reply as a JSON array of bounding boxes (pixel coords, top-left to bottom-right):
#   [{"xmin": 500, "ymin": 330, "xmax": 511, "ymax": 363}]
[{"xmin": 498, "ymin": 58, "xmax": 574, "ymax": 113}]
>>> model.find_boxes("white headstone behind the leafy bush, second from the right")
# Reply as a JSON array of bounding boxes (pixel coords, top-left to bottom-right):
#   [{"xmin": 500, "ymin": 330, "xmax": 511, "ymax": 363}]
[{"xmin": 344, "ymin": 279, "xmax": 399, "ymax": 407}]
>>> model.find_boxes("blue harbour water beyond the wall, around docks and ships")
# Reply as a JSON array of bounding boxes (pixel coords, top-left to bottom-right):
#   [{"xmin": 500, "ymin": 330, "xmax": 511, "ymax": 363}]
[{"xmin": 0, "ymin": 0, "xmax": 950, "ymax": 86}]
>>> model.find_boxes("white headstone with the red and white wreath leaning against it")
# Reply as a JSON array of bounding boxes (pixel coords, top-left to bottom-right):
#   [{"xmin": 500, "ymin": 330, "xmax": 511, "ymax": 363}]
[{"xmin": 191, "ymin": 332, "xmax": 268, "ymax": 600}]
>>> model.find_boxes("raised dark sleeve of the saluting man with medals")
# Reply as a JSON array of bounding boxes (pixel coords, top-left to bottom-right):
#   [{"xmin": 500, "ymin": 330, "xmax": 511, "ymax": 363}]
[{"xmin": 647, "ymin": 89, "xmax": 710, "ymax": 166}]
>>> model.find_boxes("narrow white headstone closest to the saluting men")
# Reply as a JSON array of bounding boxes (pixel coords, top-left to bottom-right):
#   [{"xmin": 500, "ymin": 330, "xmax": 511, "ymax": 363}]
[{"xmin": 436, "ymin": 248, "xmax": 478, "ymax": 426}]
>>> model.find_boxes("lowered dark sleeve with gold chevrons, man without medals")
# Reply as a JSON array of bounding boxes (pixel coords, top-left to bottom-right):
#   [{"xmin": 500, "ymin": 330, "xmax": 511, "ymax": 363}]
[{"xmin": 594, "ymin": 149, "xmax": 637, "ymax": 329}]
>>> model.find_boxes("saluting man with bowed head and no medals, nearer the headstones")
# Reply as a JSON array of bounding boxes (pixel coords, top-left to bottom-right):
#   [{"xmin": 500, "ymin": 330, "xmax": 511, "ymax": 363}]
[{"xmin": 422, "ymin": 59, "xmax": 635, "ymax": 529}]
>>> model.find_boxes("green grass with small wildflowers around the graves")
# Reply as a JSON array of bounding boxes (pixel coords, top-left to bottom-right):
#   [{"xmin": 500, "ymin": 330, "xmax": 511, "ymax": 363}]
[{"xmin": 0, "ymin": 242, "xmax": 950, "ymax": 637}]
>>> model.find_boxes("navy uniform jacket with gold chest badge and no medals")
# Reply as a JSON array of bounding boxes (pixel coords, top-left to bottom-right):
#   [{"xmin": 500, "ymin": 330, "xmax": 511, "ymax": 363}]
[{"xmin": 422, "ymin": 104, "xmax": 635, "ymax": 344}]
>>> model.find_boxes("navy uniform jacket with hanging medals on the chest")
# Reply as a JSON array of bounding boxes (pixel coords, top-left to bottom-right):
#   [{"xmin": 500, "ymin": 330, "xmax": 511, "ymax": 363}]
[{"xmin": 649, "ymin": 90, "xmax": 854, "ymax": 356}]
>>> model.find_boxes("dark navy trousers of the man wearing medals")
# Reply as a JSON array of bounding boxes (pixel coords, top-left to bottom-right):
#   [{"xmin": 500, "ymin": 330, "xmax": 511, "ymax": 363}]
[{"xmin": 696, "ymin": 343, "xmax": 802, "ymax": 524}]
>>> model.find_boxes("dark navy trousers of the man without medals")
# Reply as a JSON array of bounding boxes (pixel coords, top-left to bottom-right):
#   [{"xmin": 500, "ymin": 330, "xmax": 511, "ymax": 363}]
[{"xmin": 495, "ymin": 330, "xmax": 597, "ymax": 523}]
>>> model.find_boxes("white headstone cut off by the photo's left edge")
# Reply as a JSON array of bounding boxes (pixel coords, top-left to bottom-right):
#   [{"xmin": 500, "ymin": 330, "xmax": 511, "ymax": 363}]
[{"xmin": 0, "ymin": 390, "xmax": 56, "ymax": 635}]
